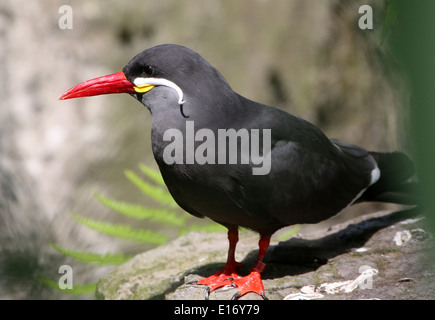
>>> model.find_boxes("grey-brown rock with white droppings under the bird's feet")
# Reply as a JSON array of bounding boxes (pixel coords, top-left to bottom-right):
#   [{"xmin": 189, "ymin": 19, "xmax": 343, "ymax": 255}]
[{"xmin": 96, "ymin": 210, "xmax": 435, "ymax": 300}]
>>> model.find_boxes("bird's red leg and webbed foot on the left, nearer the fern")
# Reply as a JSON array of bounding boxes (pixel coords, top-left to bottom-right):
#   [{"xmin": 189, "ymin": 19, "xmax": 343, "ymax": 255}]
[{"xmin": 197, "ymin": 227, "xmax": 241, "ymax": 293}]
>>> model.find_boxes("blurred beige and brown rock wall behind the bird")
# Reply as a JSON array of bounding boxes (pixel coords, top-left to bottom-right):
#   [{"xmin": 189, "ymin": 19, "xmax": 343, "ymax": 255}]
[{"xmin": 0, "ymin": 0, "xmax": 408, "ymax": 299}]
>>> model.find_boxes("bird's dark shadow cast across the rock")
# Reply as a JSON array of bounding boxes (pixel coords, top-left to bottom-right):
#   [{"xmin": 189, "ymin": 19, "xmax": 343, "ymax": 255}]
[{"xmin": 188, "ymin": 207, "xmax": 422, "ymax": 279}]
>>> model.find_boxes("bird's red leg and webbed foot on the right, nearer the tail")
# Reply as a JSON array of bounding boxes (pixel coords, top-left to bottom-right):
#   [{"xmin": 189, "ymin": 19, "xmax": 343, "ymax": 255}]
[{"xmin": 232, "ymin": 236, "xmax": 270, "ymax": 299}]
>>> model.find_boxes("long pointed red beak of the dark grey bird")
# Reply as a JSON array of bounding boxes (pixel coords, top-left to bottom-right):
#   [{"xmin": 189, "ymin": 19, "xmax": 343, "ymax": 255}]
[{"xmin": 59, "ymin": 71, "xmax": 136, "ymax": 100}]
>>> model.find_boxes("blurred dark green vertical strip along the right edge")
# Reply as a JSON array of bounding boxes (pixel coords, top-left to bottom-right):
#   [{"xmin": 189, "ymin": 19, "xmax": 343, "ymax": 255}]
[{"xmin": 391, "ymin": 0, "xmax": 435, "ymax": 261}]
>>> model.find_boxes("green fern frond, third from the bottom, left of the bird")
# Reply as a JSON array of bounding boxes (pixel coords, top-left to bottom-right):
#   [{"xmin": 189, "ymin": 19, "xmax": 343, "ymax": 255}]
[{"xmin": 71, "ymin": 213, "xmax": 167, "ymax": 245}]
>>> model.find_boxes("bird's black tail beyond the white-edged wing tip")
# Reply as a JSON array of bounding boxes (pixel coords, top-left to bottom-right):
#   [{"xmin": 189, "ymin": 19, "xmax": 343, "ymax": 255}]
[{"xmin": 358, "ymin": 152, "xmax": 418, "ymax": 205}]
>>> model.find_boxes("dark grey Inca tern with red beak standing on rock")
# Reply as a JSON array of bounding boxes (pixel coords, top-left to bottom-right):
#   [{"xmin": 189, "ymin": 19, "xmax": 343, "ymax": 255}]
[{"xmin": 59, "ymin": 44, "xmax": 416, "ymax": 299}]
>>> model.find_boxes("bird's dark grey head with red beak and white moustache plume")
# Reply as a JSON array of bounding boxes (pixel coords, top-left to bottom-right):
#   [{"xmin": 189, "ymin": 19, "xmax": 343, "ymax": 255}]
[{"xmin": 59, "ymin": 44, "xmax": 232, "ymax": 117}]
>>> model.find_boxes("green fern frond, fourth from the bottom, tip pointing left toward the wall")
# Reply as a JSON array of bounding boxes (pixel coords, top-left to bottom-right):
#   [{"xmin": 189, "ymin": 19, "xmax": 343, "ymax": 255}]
[{"xmin": 94, "ymin": 192, "xmax": 186, "ymax": 227}]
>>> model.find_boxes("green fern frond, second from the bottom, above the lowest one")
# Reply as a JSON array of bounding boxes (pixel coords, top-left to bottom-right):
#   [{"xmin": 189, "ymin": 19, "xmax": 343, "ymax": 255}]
[{"xmin": 50, "ymin": 243, "xmax": 132, "ymax": 265}]
